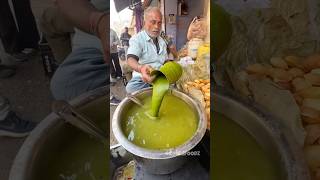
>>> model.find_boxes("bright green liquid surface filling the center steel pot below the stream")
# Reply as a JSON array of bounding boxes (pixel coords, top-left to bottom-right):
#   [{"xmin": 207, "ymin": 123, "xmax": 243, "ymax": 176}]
[{"xmin": 121, "ymin": 94, "xmax": 199, "ymax": 150}]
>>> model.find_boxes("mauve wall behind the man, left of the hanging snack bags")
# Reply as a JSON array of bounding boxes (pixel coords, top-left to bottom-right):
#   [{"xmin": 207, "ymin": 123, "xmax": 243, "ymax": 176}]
[{"xmin": 176, "ymin": 0, "xmax": 205, "ymax": 50}]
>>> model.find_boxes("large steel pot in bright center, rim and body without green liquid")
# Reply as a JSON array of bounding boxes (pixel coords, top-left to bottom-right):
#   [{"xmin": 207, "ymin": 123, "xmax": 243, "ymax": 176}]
[{"xmin": 112, "ymin": 88, "xmax": 207, "ymax": 174}]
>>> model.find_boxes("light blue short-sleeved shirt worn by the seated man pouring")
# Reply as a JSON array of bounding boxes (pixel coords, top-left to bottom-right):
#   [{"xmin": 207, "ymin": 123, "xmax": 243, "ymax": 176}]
[{"xmin": 128, "ymin": 30, "xmax": 168, "ymax": 76}]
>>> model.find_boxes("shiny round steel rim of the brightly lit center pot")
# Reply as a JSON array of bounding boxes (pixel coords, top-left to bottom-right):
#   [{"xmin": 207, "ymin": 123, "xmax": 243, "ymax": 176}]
[{"xmin": 112, "ymin": 87, "xmax": 207, "ymax": 159}]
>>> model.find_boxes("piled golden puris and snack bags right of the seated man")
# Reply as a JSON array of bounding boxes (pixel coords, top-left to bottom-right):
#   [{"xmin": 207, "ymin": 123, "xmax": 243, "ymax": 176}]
[{"xmin": 176, "ymin": 1, "xmax": 210, "ymax": 129}]
